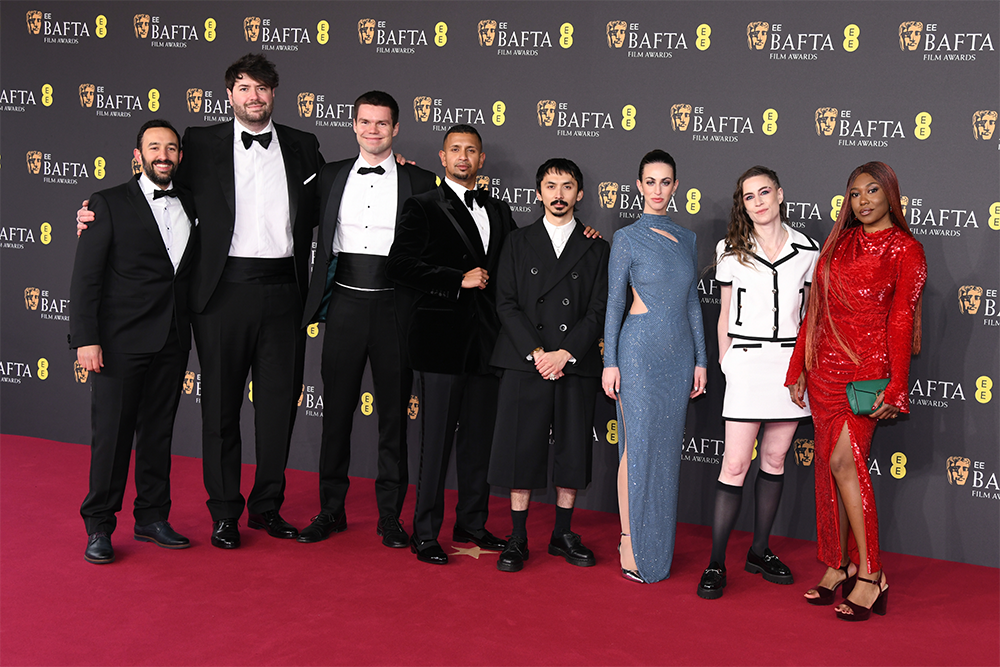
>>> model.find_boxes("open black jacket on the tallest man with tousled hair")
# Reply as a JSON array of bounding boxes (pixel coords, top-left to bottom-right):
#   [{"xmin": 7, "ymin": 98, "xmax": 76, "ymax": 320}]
[{"xmin": 174, "ymin": 121, "xmax": 323, "ymax": 313}]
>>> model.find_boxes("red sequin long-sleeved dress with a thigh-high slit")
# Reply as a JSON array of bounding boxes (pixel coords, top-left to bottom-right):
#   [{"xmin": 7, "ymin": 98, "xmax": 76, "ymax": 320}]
[{"xmin": 785, "ymin": 226, "xmax": 927, "ymax": 572}]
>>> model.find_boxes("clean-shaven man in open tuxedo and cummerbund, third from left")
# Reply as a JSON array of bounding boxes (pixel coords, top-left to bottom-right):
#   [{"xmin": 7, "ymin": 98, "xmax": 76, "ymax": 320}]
[{"xmin": 299, "ymin": 90, "xmax": 436, "ymax": 548}]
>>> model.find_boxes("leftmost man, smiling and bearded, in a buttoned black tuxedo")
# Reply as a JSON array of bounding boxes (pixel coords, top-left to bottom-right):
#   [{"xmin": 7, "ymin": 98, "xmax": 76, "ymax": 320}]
[{"xmin": 69, "ymin": 120, "xmax": 197, "ymax": 564}]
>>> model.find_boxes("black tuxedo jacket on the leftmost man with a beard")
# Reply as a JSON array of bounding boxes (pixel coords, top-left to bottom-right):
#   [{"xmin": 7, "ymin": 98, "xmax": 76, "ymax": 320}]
[{"xmin": 69, "ymin": 176, "xmax": 198, "ymax": 354}]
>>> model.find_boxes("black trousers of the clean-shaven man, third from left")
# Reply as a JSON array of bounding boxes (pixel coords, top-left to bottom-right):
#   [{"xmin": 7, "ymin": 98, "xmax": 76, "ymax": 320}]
[{"xmin": 319, "ymin": 285, "xmax": 413, "ymax": 518}]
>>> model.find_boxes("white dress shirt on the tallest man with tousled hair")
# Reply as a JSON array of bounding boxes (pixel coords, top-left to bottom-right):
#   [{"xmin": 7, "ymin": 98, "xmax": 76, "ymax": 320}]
[{"xmin": 229, "ymin": 118, "xmax": 292, "ymax": 258}]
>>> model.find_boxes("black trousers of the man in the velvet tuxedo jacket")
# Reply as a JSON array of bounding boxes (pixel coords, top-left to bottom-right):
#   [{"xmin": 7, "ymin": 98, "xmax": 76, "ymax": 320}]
[{"xmin": 413, "ymin": 371, "xmax": 500, "ymax": 540}]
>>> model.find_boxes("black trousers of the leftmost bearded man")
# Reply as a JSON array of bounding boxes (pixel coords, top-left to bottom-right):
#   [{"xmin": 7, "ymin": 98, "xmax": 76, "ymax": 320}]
[{"xmin": 80, "ymin": 325, "xmax": 188, "ymax": 535}]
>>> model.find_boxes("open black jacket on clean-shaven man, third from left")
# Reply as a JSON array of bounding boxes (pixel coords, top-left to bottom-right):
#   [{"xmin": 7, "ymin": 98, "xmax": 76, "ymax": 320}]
[{"xmin": 302, "ymin": 157, "xmax": 437, "ymax": 326}]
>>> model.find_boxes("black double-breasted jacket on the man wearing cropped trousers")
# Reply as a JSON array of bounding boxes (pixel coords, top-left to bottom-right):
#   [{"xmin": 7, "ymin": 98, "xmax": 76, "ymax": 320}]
[{"xmin": 491, "ymin": 218, "xmax": 611, "ymax": 377}]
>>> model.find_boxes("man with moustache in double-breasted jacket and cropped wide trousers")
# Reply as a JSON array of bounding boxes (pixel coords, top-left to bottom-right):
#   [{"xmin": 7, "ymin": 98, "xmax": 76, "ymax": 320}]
[{"xmin": 489, "ymin": 158, "xmax": 611, "ymax": 572}]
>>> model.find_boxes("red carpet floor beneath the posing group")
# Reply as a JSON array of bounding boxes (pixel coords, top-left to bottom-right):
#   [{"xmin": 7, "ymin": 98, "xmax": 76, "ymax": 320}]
[{"xmin": 0, "ymin": 436, "xmax": 1000, "ymax": 666}]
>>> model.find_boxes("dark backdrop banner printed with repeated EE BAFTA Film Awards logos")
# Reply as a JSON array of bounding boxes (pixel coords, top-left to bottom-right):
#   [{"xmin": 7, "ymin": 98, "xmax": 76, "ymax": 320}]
[{"xmin": 0, "ymin": 0, "xmax": 1000, "ymax": 566}]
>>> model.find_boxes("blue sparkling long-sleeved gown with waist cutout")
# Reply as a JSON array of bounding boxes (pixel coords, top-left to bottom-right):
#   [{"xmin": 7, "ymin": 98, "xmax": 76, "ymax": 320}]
[{"xmin": 604, "ymin": 214, "xmax": 708, "ymax": 583}]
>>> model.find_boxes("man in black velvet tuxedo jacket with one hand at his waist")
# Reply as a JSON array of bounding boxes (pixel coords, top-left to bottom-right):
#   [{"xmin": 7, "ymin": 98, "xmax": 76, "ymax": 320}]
[{"xmin": 386, "ymin": 125, "xmax": 514, "ymax": 565}]
